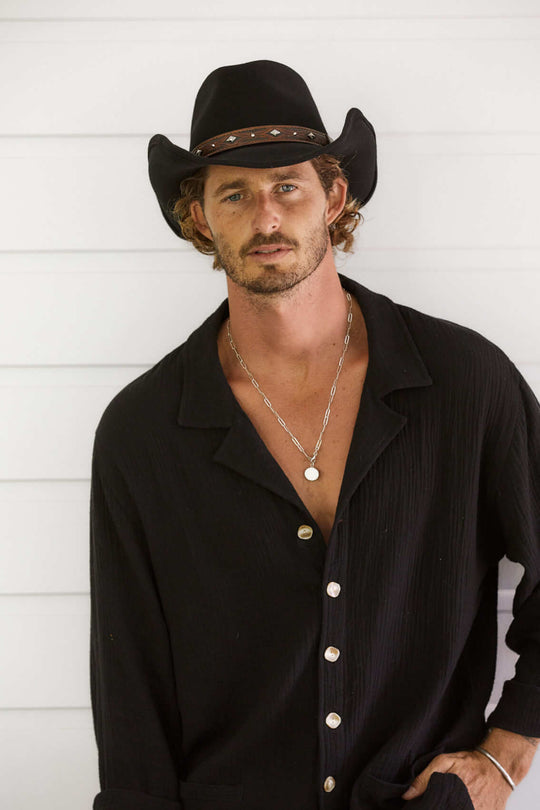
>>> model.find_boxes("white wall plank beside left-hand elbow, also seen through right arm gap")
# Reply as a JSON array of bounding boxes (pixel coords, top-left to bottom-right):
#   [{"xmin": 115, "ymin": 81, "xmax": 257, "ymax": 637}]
[{"xmin": 0, "ymin": 480, "xmax": 523, "ymax": 592}]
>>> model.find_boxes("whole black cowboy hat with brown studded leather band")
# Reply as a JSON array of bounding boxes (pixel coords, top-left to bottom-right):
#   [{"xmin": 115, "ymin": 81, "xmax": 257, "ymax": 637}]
[{"xmin": 148, "ymin": 59, "xmax": 377, "ymax": 238}]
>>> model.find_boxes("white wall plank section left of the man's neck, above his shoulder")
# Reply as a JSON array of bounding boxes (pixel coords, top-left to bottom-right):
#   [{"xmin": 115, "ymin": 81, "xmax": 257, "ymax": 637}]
[{"xmin": 0, "ymin": 266, "xmax": 227, "ymax": 364}]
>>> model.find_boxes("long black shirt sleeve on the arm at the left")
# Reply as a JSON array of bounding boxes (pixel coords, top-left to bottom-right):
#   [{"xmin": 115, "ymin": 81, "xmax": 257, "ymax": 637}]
[{"xmin": 90, "ymin": 426, "xmax": 182, "ymax": 810}]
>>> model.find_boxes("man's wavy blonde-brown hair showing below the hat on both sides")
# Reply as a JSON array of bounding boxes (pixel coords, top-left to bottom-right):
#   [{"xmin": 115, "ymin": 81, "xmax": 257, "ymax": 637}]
[{"xmin": 169, "ymin": 150, "xmax": 364, "ymax": 270}]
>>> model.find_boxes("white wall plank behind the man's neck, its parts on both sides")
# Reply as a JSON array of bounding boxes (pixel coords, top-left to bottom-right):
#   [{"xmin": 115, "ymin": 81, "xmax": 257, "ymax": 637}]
[{"xmin": 0, "ymin": 268, "xmax": 540, "ymax": 366}]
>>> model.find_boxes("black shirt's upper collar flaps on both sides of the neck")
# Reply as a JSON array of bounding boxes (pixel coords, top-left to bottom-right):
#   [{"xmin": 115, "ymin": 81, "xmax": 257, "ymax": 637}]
[{"xmin": 177, "ymin": 273, "xmax": 433, "ymax": 428}]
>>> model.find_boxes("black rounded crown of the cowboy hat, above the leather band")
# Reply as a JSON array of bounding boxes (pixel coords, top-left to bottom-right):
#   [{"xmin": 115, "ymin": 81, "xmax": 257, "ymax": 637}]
[{"xmin": 190, "ymin": 59, "xmax": 327, "ymax": 149}]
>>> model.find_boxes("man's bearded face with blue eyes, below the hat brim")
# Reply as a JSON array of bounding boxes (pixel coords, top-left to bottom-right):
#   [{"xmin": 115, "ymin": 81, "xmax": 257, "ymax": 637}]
[{"xmin": 188, "ymin": 161, "xmax": 345, "ymax": 294}]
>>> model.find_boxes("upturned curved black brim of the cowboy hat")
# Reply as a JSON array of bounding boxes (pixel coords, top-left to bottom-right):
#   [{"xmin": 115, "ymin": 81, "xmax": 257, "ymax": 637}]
[{"xmin": 148, "ymin": 107, "xmax": 377, "ymax": 239}]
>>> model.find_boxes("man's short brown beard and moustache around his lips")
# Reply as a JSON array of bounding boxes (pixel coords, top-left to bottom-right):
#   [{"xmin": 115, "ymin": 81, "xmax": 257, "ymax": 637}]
[{"xmin": 212, "ymin": 213, "xmax": 329, "ymax": 295}]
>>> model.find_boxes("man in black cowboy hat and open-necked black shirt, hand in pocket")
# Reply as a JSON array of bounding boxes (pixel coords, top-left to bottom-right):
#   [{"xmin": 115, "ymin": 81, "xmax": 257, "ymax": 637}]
[{"xmin": 91, "ymin": 61, "xmax": 540, "ymax": 810}]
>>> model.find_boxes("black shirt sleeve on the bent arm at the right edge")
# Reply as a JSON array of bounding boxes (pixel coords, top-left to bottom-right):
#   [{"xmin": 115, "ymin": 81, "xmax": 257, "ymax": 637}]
[{"xmin": 487, "ymin": 369, "xmax": 540, "ymax": 737}]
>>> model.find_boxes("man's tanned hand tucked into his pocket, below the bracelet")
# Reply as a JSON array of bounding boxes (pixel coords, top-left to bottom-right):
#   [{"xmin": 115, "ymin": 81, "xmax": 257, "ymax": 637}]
[{"xmin": 402, "ymin": 751, "xmax": 512, "ymax": 810}]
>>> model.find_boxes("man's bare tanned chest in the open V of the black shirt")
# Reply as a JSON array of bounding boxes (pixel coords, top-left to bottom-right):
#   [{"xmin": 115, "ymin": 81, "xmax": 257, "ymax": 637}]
[{"xmin": 224, "ymin": 361, "xmax": 367, "ymax": 543}]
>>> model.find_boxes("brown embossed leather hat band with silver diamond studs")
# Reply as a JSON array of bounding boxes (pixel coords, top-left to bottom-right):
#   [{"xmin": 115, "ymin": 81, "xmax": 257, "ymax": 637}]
[{"xmin": 191, "ymin": 124, "xmax": 330, "ymax": 157}]
